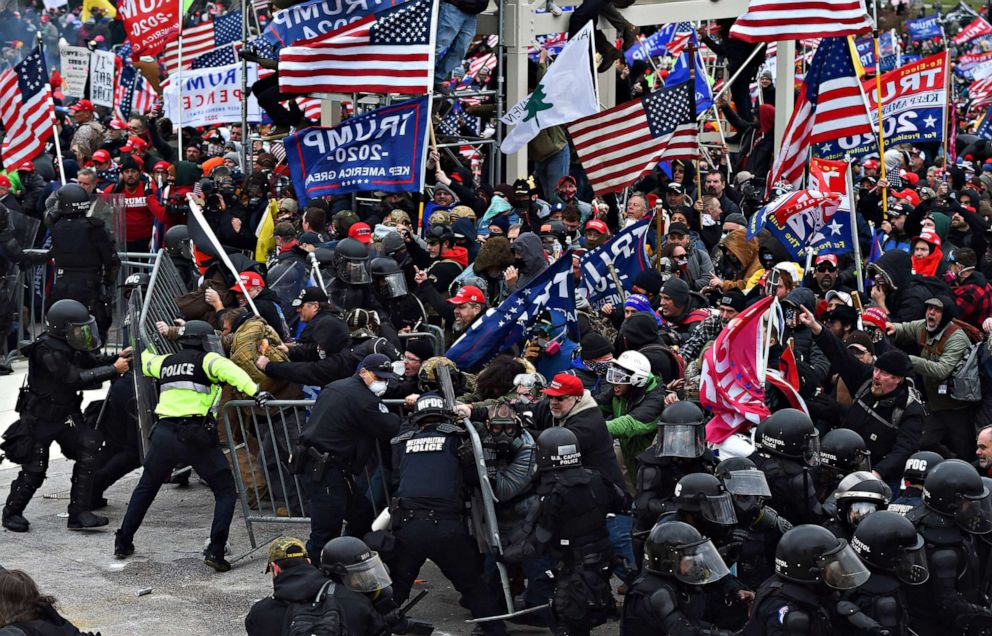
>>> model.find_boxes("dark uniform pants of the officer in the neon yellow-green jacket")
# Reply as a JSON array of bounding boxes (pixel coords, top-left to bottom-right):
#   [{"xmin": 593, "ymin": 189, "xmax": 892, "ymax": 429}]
[{"xmin": 120, "ymin": 421, "xmax": 238, "ymax": 556}]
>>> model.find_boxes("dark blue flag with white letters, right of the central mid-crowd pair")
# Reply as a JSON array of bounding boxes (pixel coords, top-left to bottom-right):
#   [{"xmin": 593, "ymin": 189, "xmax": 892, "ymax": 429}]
[{"xmin": 579, "ymin": 219, "xmax": 651, "ymax": 311}]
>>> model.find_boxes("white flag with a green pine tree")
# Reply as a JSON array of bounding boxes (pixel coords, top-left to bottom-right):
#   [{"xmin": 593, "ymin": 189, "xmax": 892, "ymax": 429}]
[{"xmin": 499, "ymin": 21, "xmax": 599, "ymax": 155}]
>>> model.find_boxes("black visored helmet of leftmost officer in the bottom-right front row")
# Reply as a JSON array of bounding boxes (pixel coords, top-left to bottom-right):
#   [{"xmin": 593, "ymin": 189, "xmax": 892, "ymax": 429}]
[{"xmin": 644, "ymin": 521, "xmax": 730, "ymax": 585}]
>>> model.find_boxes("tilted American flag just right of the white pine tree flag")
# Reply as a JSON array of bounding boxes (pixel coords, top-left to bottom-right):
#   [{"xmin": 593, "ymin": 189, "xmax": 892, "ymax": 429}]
[{"xmin": 568, "ymin": 82, "xmax": 699, "ymax": 194}]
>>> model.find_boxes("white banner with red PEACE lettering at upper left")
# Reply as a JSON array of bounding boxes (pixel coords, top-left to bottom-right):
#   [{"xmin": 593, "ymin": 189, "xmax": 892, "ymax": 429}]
[{"xmin": 162, "ymin": 64, "xmax": 262, "ymax": 126}]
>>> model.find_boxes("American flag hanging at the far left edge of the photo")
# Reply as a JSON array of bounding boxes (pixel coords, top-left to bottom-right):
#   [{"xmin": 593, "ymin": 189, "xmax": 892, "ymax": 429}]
[{"xmin": 0, "ymin": 46, "xmax": 55, "ymax": 169}]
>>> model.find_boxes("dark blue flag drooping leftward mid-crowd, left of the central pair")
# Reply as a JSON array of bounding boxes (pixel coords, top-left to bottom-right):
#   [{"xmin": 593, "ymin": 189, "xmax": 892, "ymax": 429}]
[{"xmin": 444, "ymin": 254, "xmax": 579, "ymax": 369}]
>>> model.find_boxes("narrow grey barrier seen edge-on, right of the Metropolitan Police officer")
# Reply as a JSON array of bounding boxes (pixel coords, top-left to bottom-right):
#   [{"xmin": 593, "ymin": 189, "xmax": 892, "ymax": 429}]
[{"xmin": 434, "ymin": 364, "xmax": 513, "ymax": 612}]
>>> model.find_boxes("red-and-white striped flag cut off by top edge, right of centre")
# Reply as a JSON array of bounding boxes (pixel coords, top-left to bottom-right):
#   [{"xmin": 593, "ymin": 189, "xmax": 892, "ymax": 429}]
[{"xmin": 730, "ymin": 0, "xmax": 871, "ymax": 42}]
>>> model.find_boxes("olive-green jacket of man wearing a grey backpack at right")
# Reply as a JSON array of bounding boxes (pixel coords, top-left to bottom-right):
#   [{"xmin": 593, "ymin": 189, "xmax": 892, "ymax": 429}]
[{"xmin": 895, "ymin": 320, "xmax": 971, "ymax": 412}]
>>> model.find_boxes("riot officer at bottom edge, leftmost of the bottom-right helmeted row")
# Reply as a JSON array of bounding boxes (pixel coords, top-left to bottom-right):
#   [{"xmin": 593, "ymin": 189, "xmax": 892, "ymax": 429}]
[{"xmin": 620, "ymin": 521, "xmax": 730, "ymax": 636}]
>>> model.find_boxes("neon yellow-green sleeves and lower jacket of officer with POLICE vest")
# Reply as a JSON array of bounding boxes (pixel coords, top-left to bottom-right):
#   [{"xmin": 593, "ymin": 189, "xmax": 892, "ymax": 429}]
[{"xmin": 141, "ymin": 349, "xmax": 258, "ymax": 417}]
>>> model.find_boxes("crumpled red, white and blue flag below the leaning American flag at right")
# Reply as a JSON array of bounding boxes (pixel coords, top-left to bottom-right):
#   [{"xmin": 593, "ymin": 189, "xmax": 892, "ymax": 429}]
[{"xmin": 747, "ymin": 190, "xmax": 840, "ymax": 259}]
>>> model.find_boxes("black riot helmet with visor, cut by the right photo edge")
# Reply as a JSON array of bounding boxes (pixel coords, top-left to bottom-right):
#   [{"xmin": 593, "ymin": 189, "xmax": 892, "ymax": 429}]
[{"xmin": 923, "ymin": 459, "xmax": 992, "ymax": 534}]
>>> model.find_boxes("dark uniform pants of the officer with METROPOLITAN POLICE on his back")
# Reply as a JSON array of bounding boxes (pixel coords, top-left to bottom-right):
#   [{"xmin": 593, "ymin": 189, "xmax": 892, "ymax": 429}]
[{"xmin": 390, "ymin": 511, "xmax": 506, "ymax": 634}]
